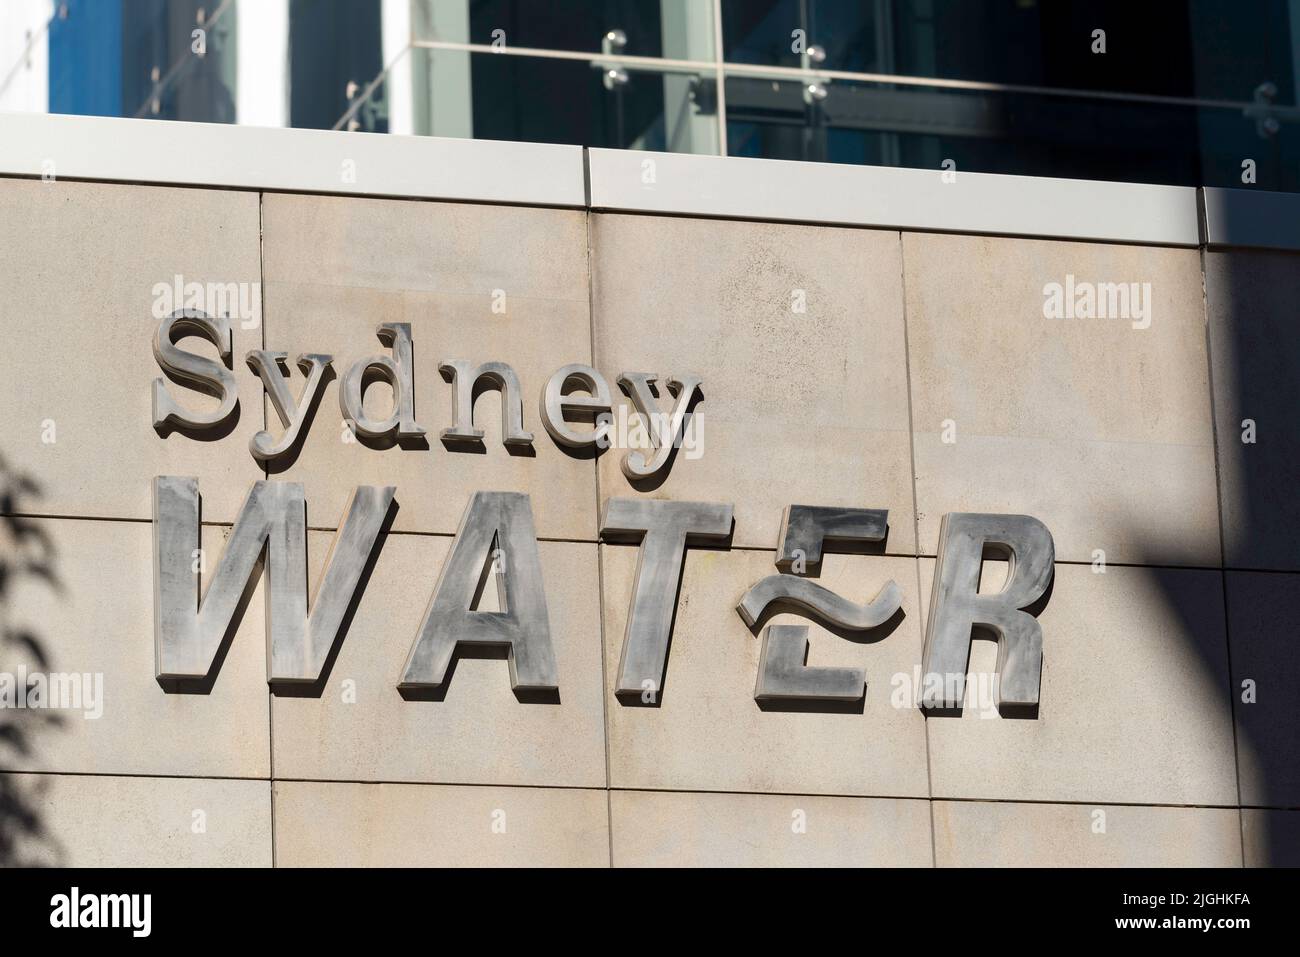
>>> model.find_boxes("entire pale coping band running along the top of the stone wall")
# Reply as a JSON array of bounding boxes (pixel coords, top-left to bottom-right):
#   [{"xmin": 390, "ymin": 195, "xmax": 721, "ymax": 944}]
[{"xmin": 0, "ymin": 113, "xmax": 1279, "ymax": 250}]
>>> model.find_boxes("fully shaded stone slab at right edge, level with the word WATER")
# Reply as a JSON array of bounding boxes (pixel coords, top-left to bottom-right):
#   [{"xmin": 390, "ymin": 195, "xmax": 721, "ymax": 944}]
[{"xmin": 1227, "ymin": 572, "xmax": 1300, "ymax": 807}]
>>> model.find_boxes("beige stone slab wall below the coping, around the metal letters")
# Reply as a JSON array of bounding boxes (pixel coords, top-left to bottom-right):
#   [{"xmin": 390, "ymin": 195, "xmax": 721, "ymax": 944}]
[{"xmin": 0, "ymin": 171, "xmax": 1300, "ymax": 866}]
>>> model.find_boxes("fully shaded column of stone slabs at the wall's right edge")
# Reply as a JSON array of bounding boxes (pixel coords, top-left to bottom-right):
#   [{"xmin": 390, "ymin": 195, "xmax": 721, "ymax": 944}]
[{"xmin": 1186, "ymin": 250, "xmax": 1300, "ymax": 866}]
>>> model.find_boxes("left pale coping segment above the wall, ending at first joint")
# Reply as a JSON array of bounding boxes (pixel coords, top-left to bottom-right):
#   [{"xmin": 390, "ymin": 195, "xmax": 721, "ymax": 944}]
[{"xmin": 0, "ymin": 113, "xmax": 586, "ymax": 207}]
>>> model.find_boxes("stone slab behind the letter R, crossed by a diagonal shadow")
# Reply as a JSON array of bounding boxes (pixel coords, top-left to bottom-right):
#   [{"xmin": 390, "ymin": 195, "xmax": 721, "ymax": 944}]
[{"xmin": 920, "ymin": 559, "xmax": 1236, "ymax": 805}]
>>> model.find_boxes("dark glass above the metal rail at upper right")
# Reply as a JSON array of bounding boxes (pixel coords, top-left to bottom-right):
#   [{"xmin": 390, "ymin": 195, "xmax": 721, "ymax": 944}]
[{"xmin": 722, "ymin": 0, "xmax": 1300, "ymax": 104}]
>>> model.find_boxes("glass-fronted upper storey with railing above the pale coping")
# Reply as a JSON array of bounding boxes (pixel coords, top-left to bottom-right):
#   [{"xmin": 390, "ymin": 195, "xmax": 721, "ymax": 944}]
[{"xmin": 0, "ymin": 0, "xmax": 1300, "ymax": 191}]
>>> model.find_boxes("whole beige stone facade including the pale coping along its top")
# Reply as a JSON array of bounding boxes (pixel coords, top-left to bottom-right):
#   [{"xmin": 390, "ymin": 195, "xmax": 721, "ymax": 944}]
[{"xmin": 0, "ymin": 116, "xmax": 1300, "ymax": 867}]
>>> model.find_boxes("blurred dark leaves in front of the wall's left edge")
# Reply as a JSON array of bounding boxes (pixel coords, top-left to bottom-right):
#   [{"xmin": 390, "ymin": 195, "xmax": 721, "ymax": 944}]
[{"xmin": 0, "ymin": 456, "xmax": 62, "ymax": 867}]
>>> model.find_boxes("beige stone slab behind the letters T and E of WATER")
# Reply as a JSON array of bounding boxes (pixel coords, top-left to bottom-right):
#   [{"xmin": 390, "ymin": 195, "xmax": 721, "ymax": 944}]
[{"xmin": 601, "ymin": 545, "xmax": 928, "ymax": 797}]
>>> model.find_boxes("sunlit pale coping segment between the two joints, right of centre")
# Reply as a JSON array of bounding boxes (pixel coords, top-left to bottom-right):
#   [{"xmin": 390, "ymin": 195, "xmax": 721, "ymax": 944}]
[{"xmin": 588, "ymin": 150, "xmax": 1200, "ymax": 246}]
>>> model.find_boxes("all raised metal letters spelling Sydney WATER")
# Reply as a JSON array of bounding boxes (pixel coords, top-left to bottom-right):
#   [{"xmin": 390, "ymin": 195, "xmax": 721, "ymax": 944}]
[{"xmin": 152, "ymin": 317, "xmax": 1054, "ymax": 715}]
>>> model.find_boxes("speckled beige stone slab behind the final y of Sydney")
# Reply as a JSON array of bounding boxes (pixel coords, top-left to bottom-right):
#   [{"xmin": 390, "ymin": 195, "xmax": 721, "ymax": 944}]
[{"xmin": 592, "ymin": 215, "xmax": 915, "ymax": 554}]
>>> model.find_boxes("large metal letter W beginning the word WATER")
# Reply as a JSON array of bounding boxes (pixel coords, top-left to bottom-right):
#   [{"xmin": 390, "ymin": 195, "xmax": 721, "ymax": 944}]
[{"xmin": 153, "ymin": 476, "xmax": 394, "ymax": 684}]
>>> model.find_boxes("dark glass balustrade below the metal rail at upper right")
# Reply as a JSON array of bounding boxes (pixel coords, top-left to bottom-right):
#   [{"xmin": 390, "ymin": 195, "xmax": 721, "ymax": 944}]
[{"xmin": 727, "ymin": 69, "xmax": 1300, "ymax": 190}]
